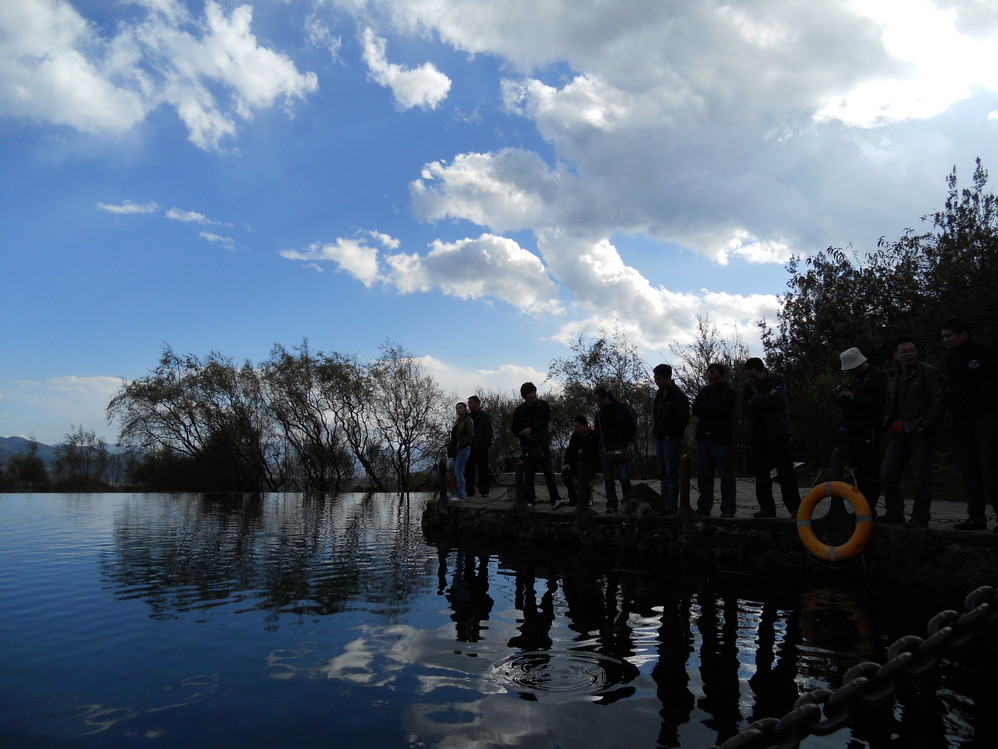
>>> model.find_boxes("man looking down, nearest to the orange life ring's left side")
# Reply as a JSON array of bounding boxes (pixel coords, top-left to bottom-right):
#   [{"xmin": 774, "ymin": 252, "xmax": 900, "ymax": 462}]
[{"xmin": 741, "ymin": 356, "xmax": 800, "ymax": 518}]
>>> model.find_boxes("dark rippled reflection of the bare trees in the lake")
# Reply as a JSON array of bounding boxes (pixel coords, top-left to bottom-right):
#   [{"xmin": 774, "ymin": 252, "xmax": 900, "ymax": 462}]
[{"xmin": 102, "ymin": 494, "xmax": 434, "ymax": 618}]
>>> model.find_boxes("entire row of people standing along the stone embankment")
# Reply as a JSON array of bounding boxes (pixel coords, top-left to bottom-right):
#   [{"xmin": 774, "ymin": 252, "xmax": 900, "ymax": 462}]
[{"xmin": 451, "ymin": 319, "xmax": 998, "ymax": 533}]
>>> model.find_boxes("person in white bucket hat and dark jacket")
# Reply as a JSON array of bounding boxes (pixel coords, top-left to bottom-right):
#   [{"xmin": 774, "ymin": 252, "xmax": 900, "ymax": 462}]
[{"xmin": 835, "ymin": 347, "xmax": 888, "ymax": 508}]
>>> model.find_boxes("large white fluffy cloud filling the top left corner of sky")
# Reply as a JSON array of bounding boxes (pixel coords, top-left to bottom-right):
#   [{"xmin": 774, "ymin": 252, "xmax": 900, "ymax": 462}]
[{"xmin": 0, "ymin": 0, "xmax": 318, "ymax": 149}]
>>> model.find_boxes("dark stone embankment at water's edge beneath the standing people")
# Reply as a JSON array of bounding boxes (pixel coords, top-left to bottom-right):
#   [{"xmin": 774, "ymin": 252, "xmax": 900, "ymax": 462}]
[{"xmin": 423, "ymin": 480, "xmax": 998, "ymax": 591}]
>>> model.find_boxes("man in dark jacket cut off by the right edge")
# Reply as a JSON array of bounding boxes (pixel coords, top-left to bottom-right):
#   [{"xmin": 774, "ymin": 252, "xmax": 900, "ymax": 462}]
[{"xmin": 943, "ymin": 318, "xmax": 998, "ymax": 533}]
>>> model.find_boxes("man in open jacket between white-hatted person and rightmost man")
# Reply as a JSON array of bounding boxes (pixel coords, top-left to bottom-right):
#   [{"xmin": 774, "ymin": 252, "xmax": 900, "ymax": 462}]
[{"xmin": 877, "ymin": 336, "xmax": 945, "ymax": 528}]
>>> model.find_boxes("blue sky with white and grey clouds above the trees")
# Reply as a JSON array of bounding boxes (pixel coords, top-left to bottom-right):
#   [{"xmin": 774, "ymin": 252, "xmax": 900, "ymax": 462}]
[{"xmin": 0, "ymin": 0, "xmax": 998, "ymax": 444}]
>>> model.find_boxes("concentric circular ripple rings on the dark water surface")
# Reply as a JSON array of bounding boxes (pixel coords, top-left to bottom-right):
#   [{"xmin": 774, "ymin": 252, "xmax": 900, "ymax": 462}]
[{"xmin": 485, "ymin": 650, "xmax": 638, "ymax": 701}]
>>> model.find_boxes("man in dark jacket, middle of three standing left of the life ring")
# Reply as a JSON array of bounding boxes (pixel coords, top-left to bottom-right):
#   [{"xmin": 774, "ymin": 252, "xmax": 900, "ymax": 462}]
[{"xmin": 692, "ymin": 363, "xmax": 738, "ymax": 518}]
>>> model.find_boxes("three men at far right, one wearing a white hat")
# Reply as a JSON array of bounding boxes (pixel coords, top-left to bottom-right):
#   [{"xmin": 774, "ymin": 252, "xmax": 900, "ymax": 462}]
[{"xmin": 835, "ymin": 318, "xmax": 998, "ymax": 533}]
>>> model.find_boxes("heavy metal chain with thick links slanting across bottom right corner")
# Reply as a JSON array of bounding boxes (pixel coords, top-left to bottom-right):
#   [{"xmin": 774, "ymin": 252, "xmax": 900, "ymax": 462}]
[{"xmin": 709, "ymin": 585, "xmax": 998, "ymax": 749}]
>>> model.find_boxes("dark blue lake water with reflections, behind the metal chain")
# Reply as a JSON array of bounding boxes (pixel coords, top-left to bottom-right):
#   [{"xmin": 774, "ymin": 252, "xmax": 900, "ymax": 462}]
[{"xmin": 0, "ymin": 494, "xmax": 998, "ymax": 749}]
